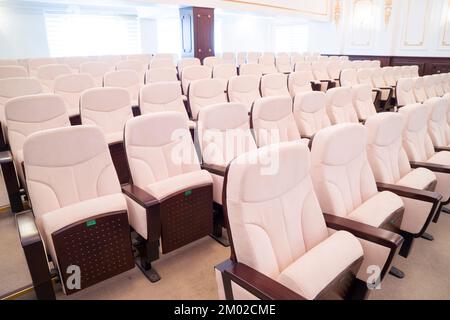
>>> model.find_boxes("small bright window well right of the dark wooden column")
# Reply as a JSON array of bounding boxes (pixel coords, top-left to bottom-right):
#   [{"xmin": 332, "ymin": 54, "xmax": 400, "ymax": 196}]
[{"xmin": 274, "ymin": 25, "xmax": 309, "ymax": 52}]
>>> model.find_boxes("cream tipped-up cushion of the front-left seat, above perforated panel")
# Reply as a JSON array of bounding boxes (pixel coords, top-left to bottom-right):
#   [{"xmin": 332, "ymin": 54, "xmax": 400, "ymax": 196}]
[{"xmin": 36, "ymin": 193, "xmax": 127, "ymax": 263}]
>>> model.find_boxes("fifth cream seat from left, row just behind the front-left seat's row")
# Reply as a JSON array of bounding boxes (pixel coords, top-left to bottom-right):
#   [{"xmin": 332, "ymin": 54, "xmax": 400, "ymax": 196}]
[{"xmin": 228, "ymin": 75, "xmax": 261, "ymax": 112}]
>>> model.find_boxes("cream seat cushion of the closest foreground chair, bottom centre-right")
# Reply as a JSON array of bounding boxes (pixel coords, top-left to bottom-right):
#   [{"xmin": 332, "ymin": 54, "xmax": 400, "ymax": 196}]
[{"xmin": 277, "ymin": 231, "xmax": 363, "ymax": 300}]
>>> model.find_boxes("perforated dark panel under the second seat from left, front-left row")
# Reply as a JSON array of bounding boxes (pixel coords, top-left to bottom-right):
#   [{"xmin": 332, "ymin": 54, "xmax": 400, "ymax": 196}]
[{"xmin": 160, "ymin": 185, "xmax": 213, "ymax": 253}]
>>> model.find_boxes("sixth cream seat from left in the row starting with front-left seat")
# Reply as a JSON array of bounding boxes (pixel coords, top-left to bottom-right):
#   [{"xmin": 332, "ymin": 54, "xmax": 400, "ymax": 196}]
[{"xmin": 326, "ymin": 87, "xmax": 359, "ymax": 124}]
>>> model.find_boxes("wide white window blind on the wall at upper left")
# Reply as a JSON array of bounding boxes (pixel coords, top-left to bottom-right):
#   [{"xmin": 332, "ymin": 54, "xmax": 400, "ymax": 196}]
[{"xmin": 45, "ymin": 12, "xmax": 141, "ymax": 57}]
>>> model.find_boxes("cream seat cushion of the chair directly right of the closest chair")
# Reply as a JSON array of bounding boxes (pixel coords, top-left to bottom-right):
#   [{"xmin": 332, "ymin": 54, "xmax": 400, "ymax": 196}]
[{"xmin": 348, "ymin": 191, "xmax": 403, "ymax": 228}]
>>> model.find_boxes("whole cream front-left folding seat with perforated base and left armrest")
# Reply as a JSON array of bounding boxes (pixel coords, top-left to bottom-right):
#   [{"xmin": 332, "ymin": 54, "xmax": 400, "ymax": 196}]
[{"xmin": 17, "ymin": 126, "xmax": 134, "ymax": 299}]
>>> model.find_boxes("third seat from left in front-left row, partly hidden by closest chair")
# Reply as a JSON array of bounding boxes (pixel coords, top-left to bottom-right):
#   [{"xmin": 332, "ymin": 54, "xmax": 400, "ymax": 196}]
[{"xmin": 197, "ymin": 103, "xmax": 256, "ymax": 245}]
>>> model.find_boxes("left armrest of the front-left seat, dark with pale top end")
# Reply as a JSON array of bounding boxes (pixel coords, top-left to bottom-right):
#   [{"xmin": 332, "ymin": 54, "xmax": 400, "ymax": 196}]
[{"xmin": 16, "ymin": 211, "xmax": 56, "ymax": 300}]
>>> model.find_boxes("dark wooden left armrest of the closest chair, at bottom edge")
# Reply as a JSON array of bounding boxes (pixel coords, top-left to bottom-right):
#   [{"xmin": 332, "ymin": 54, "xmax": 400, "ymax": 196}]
[{"xmin": 216, "ymin": 260, "xmax": 306, "ymax": 300}]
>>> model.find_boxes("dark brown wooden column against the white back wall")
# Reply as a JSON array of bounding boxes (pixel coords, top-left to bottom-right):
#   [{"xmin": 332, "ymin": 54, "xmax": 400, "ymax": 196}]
[{"xmin": 180, "ymin": 7, "xmax": 214, "ymax": 61}]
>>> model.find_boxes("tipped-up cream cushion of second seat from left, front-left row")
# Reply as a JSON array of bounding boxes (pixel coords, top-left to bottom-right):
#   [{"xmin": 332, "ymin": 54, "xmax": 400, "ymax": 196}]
[{"xmin": 147, "ymin": 170, "xmax": 212, "ymax": 200}]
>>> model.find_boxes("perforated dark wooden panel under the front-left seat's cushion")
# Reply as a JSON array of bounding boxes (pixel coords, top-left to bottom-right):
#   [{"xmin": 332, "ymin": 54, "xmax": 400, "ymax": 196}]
[{"xmin": 52, "ymin": 211, "xmax": 134, "ymax": 294}]
